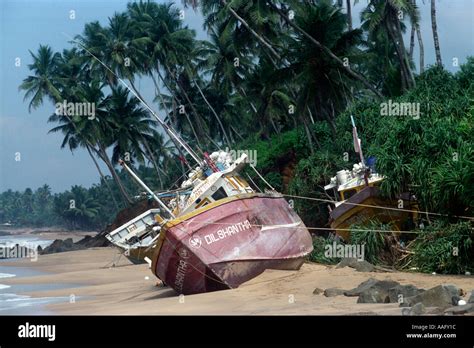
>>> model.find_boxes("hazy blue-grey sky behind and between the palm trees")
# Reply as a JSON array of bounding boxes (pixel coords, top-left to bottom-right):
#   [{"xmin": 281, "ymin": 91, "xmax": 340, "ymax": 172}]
[{"xmin": 0, "ymin": 0, "xmax": 474, "ymax": 192}]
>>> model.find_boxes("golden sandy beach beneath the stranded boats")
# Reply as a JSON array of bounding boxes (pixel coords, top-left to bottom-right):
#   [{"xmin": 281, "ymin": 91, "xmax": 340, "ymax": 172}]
[{"xmin": 0, "ymin": 247, "xmax": 474, "ymax": 315}]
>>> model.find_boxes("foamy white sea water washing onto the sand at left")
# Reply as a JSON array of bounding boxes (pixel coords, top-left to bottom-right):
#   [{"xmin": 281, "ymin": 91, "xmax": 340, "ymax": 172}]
[{"xmin": 0, "ymin": 236, "xmax": 79, "ymax": 315}]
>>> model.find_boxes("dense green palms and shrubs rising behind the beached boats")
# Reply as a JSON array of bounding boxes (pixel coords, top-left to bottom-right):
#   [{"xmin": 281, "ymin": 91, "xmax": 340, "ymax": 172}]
[{"xmin": 0, "ymin": 0, "xmax": 474, "ymax": 273}]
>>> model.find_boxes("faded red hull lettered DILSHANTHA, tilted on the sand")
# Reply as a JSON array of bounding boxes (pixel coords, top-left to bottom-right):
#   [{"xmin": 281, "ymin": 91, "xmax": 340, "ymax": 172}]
[{"xmin": 152, "ymin": 195, "xmax": 313, "ymax": 294}]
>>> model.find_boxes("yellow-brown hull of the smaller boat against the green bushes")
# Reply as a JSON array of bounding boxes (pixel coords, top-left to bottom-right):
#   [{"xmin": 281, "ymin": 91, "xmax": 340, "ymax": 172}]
[{"xmin": 330, "ymin": 187, "xmax": 418, "ymax": 242}]
